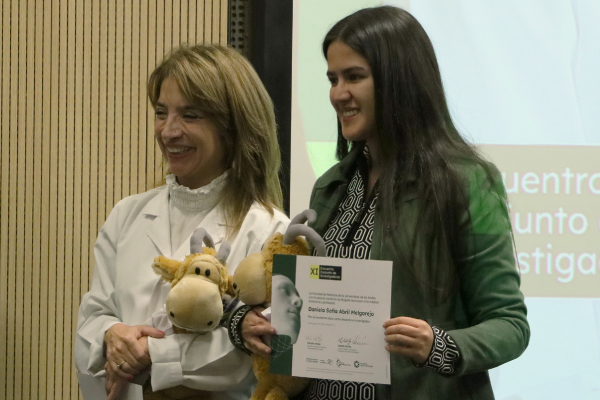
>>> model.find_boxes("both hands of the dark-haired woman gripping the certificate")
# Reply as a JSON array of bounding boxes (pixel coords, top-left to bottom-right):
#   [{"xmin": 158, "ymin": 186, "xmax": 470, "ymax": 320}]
[{"xmin": 242, "ymin": 307, "xmax": 433, "ymax": 364}]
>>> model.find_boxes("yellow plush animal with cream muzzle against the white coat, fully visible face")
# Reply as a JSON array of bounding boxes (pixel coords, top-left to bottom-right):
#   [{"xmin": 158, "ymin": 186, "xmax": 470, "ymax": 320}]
[{"xmin": 152, "ymin": 228, "xmax": 234, "ymax": 333}]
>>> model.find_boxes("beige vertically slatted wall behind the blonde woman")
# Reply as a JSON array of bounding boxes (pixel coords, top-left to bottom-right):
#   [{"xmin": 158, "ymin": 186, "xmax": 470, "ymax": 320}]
[{"xmin": 0, "ymin": 0, "xmax": 227, "ymax": 399}]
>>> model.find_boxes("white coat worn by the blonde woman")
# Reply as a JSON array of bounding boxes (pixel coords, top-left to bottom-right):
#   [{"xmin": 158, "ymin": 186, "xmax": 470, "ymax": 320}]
[{"xmin": 75, "ymin": 186, "xmax": 289, "ymax": 400}]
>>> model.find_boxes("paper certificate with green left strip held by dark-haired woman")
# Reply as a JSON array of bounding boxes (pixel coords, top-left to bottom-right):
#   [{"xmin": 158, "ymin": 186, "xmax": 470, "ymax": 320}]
[{"xmin": 270, "ymin": 254, "xmax": 392, "ymax": 384}]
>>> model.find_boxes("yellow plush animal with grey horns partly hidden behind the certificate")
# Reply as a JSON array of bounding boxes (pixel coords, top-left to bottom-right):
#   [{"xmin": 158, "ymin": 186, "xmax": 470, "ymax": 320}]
[{"xmin": 233, "ymin": 210, "xmax": 326, "ymax": 400}]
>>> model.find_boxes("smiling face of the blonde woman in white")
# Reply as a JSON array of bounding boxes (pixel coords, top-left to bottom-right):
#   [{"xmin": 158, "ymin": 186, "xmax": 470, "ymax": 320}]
[{"xmin": 154, "ymin": 77, "xmax": 226, "ymax": 189}]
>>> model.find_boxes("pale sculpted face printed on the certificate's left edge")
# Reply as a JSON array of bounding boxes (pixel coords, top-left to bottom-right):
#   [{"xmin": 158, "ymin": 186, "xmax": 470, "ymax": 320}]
[{"xmin": 271, "ymin": 275, "xmax": 302, "ymax": 343}]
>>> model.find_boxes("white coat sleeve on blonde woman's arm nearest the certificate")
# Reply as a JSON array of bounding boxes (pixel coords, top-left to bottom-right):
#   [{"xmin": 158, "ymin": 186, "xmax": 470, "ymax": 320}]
[{"xmin": 148, "ymin": 208, "xmax": 289, "ymax": 391}]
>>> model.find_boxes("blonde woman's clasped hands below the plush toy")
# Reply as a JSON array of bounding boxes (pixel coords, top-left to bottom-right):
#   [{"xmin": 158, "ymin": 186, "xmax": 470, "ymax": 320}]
[{"xmin": 104, "ymin": 324, "xmax": 165, "ymax": 400}]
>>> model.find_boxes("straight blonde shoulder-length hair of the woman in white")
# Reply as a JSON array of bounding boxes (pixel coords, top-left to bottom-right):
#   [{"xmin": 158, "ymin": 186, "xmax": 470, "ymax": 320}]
[{"xmin": 148, "ymin": 44, "xmax": 283, "ymax": 236}]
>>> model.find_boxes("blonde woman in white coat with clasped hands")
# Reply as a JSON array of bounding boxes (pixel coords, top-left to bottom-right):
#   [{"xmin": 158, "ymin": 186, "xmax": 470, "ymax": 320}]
[{"xmin": 75, "ymin": 45, "xmax": 288, "ymax": 399}]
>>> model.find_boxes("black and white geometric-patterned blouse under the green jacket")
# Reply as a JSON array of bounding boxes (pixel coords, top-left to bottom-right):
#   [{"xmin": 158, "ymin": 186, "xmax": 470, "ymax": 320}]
[{"xmin": 303, "ymin": 148, "xmax": 460, "ymax": 400}]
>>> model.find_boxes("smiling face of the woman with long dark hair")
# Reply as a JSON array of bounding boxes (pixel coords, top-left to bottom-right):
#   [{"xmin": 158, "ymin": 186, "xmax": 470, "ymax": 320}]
[{"xmin": 327, "ymin": 41, "xmax": 376, "ymax": 147}]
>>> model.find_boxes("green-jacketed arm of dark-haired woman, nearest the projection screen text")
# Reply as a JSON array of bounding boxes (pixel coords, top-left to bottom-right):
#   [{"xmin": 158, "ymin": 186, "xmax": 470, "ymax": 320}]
[{"xmin": 447, "ymin": 163, "xmax": 530, "ymax": 374}]
